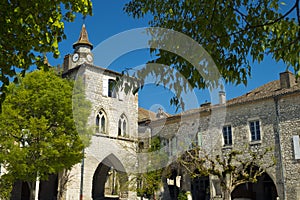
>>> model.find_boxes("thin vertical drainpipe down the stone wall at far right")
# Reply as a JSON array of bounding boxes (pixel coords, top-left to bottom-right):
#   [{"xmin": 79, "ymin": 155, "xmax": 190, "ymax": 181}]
[{"xmin": 274, "ymin": 96, "xmax": 286, "ymax": 200}]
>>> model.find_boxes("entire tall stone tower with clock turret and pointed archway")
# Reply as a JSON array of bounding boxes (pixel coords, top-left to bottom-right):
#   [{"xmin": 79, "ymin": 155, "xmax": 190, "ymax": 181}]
[{"xmin": 63, "ymin": 24, "xmax": 138, "ymax": 200}]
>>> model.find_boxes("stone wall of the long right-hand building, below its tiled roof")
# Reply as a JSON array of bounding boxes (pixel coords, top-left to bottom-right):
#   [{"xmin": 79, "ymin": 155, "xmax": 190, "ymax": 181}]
[{"xmin": 149, "ymin": 92, "xmax": 300, "ymax": 200}]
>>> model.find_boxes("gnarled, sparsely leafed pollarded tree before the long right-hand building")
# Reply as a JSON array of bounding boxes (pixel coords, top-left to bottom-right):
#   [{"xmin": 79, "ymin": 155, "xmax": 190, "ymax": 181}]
[{"xmin": 179, "ymin": 146, "xmax": 276, "ymax": 200}]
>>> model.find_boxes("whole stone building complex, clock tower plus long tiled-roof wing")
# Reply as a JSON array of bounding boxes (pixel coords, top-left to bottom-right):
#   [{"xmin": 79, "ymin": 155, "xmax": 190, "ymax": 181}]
[{"xmin": 1, "ymin": 25, "xmax": 300, "ymax": 200}]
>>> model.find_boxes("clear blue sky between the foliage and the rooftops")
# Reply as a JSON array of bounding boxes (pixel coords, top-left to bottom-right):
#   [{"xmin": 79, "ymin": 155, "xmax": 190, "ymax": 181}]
[{"xmin": 48, "ymin": 0, "xmax": 286, "ymax": 113}]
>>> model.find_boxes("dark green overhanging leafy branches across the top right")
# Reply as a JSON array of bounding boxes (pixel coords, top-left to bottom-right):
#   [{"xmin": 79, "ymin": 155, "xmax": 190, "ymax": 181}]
[{"xmin": 124, "ymin": 0, "xmax": 300, "ymax": 108}]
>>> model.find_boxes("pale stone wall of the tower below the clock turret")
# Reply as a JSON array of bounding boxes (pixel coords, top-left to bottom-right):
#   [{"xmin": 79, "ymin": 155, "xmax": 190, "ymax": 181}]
[{"xmin": 67, "ymin": 65, "xmax": 138, "ymax": 200}]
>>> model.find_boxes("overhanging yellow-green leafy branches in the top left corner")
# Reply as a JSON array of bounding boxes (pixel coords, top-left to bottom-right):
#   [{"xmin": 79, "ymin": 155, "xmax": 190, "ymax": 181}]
[{"xmin": 0, "ymin": 0, "xmax": 92, "ymax": 103}]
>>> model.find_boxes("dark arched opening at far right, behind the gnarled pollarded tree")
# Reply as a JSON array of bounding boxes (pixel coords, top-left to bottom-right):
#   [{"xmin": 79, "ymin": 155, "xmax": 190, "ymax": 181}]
[{"xmin": 231, "ymin": 173, "xmax": 278, "ymax": 200}]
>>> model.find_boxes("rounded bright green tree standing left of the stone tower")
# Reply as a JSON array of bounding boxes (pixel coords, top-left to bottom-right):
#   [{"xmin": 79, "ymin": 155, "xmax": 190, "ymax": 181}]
[{"xmin": 0, "ymin": 70, "xmax": 91, "ymax": 198}]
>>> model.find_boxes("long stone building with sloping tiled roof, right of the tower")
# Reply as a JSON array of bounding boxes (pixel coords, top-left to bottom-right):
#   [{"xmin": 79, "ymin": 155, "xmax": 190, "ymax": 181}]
[{"xmin": 140, "ymin": 71, "xmax": 300, "ymax": 200}]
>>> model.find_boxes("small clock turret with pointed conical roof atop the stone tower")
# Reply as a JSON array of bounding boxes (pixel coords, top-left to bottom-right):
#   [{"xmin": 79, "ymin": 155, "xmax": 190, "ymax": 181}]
[{"xmin": 64, "ymin": 24, "xmax": 94, "ymax": 73}]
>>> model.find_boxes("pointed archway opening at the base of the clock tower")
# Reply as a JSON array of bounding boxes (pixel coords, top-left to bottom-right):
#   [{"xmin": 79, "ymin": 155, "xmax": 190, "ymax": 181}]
[{"xmin": 92, "ymin": 154, "xmax": 128, "ymax": 200}]
